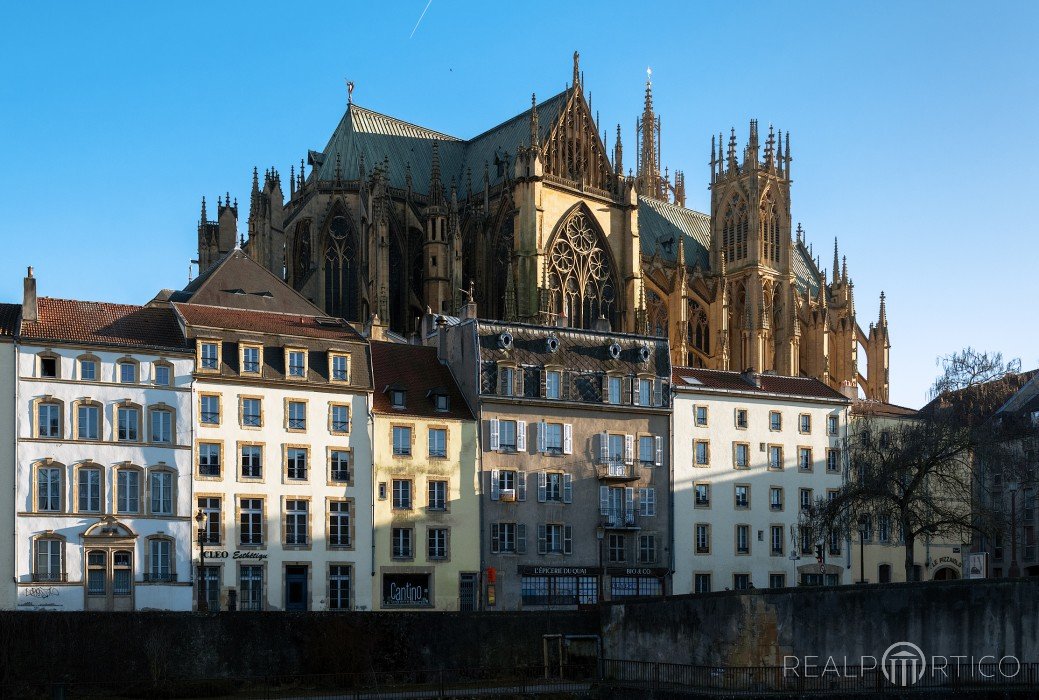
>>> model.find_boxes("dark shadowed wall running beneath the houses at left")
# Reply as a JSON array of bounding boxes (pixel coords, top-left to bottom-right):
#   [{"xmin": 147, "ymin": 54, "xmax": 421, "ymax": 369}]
[{"xmin": 0, "ymin": 611, "xmax": 598, "ymax": 684}]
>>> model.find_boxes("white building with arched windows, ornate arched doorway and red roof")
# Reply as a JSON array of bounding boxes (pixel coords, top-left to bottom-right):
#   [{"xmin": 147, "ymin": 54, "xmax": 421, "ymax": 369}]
[{"xmin": 12, "ymin": 269, "xmax": 192, "ymax": 611}]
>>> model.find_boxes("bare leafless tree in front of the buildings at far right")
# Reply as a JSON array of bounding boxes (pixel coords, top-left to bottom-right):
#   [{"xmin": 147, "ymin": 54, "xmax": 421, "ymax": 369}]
[{"xmin": 811, "ymin": 348, "xmax": 1024, "ymax": 581}]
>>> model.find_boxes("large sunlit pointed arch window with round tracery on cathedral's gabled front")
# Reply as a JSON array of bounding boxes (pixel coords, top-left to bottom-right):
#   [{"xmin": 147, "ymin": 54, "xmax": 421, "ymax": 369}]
[{"xmin": 549, "ymin": 211, "xmax": 617, "ymax": 328}]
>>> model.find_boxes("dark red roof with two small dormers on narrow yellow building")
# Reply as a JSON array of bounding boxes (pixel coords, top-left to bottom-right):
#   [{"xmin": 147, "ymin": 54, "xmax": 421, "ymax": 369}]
[{"xmin": 372, "ymin": 341, "xmax": 474, "ymax": 421}]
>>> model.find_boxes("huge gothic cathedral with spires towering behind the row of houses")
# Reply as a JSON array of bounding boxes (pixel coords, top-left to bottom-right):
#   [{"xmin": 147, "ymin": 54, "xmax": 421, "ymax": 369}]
[{"xmin": 197, "ymin": 53, "xmax": 890, "ymax": 401}]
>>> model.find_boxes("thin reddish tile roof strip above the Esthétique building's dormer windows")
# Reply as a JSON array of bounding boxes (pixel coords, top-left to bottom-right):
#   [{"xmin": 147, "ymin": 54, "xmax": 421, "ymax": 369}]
[{"xmin": 174, "ymin": 303, "xmax": 364, "ymax": 341}]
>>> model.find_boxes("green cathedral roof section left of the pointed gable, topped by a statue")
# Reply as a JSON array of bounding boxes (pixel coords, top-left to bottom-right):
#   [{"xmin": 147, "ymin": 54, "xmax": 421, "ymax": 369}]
[{"xmin": 312, "ymin": 90, "xmax": 570, "ymax": 196}]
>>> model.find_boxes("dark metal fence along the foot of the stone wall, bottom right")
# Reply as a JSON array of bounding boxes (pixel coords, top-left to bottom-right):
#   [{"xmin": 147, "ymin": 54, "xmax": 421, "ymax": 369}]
[{"xmin": 601, "ymin": 658, "xmax": 1039, "ymax": 697}]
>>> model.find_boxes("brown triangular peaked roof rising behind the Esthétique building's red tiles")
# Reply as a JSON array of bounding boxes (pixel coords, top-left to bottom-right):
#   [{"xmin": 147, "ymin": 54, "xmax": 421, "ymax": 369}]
[{"xmin": 170, "ymin": 248, "xmax": 323, "ymax": 316}]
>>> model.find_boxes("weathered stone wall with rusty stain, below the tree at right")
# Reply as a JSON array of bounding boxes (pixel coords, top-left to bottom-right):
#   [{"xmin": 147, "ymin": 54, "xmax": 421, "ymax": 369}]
[{"xmin": 603, "ymin": 581, "xmax": 1039, "ymax": 666}]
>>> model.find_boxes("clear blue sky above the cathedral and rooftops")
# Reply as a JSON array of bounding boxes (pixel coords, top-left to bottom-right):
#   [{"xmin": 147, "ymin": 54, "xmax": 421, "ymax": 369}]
[{"xmin": 0, "ymin": 0, "xmax": 1039, "ymax": 406}]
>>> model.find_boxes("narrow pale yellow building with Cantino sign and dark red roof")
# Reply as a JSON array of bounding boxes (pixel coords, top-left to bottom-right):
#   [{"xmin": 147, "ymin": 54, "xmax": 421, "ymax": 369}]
[{"xmin": 371, "ymin": 341, "xmax": 480, "ymax": 611}]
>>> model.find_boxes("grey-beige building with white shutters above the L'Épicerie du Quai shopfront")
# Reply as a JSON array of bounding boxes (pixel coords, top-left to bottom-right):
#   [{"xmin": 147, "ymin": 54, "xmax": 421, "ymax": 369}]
[{"xmin": 424, "ymin": 303, "xmax": 671, "ymax": 610}]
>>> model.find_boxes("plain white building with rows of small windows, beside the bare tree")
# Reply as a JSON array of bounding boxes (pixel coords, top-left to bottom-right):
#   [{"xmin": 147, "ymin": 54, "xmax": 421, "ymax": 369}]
[{"xmin": 672, "ymin": 368, "xmax": 851, "ymax": 593}]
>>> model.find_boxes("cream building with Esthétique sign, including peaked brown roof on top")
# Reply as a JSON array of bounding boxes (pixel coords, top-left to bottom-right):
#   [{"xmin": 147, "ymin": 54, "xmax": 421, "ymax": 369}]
[{"xmin": 170, "ymin": 250, "xmax": 372, "ymax": 611}]
